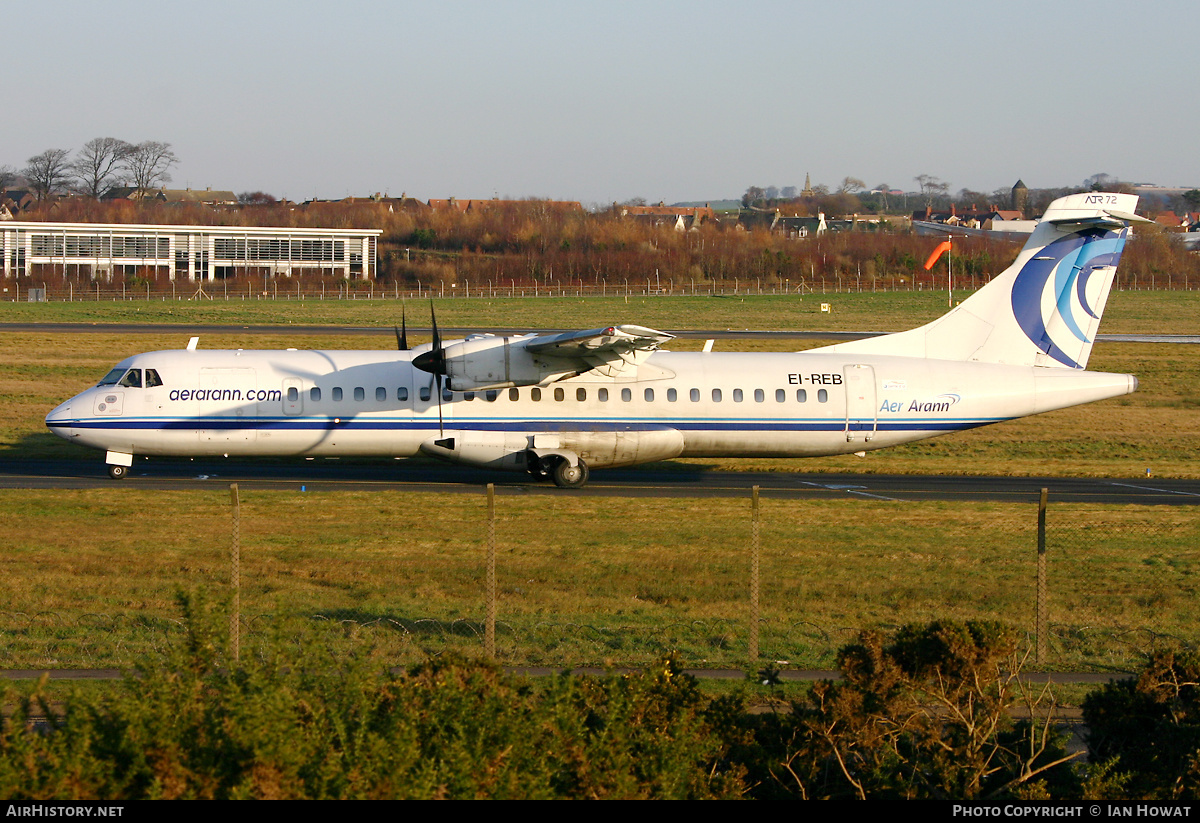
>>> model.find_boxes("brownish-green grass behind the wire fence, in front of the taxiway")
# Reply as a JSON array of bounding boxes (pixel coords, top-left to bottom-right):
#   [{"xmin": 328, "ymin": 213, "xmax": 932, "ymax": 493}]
[{"xmin": 0, "ymin": 486, "xmax": 1200, "ymax": 671}]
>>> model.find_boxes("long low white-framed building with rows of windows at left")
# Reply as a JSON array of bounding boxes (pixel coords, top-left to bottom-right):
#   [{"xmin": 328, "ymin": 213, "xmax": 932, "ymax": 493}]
[{"xmin": 0, "ymin": 221, "xmax": 383, "ymax": 281}]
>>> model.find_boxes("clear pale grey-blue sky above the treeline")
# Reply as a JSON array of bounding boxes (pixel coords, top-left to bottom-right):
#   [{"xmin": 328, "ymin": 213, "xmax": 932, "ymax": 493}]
[{"xmin": 7, "ymin": 0, "xmax": 1200, "ymax": 204}]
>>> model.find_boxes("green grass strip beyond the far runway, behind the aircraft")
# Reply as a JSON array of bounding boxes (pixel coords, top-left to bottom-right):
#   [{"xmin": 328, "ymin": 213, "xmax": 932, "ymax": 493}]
[{"xmin": 7, "ymin": 286, "xmax": 1200, "ymax": 335}]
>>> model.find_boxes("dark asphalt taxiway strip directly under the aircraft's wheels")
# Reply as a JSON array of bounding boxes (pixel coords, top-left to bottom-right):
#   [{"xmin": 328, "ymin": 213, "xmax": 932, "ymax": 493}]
[{"xmin": 0, "ymin": 456, "xmax": 1200, "ymax": 506}]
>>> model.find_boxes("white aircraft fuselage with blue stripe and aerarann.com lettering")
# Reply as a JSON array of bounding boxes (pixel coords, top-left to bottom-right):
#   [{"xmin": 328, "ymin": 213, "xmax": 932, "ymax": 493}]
[{"xmin": 47, "ymin": 350, "xmax": 1136, "ymax": 468}]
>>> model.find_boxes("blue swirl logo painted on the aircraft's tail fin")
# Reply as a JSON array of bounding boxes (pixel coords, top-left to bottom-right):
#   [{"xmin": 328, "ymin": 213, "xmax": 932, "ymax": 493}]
[{"xmin": 1012, "ymin": 229, "xmax": 1127, "ymax": 368}]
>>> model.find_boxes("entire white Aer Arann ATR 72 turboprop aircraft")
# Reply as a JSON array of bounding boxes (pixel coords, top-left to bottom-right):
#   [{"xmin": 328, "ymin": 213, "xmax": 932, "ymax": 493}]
[{"xmin": 46, "ymin": 193, "xmax": 1148, "ymax": 487}]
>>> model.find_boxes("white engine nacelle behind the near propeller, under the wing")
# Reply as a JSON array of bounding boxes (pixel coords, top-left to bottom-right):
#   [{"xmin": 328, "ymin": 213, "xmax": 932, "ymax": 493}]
[{"xmin": 444, "ymin": 336, "xmax": 577, "ymax": 391}]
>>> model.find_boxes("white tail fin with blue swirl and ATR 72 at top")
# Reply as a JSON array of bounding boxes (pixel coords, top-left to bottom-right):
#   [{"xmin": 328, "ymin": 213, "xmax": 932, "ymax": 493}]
[{"xmin": 821, "ymin": 192, "xmax": 1150, "ymax": 368}]
